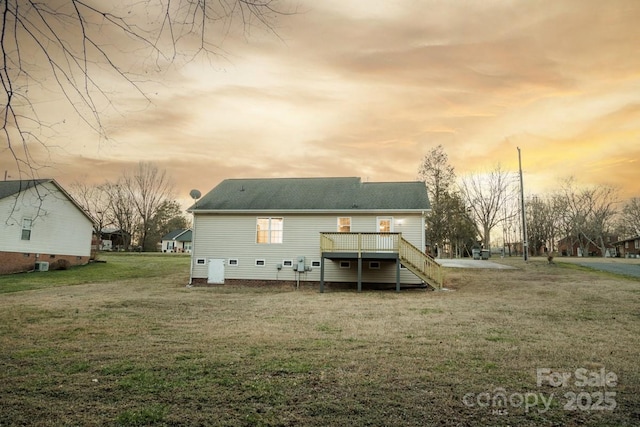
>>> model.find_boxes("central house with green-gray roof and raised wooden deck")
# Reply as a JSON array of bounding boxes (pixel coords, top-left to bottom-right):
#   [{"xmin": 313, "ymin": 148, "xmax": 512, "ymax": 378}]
[{"xmin": 188, "ymin": 178, "xmax": 442, "ymax": 291}]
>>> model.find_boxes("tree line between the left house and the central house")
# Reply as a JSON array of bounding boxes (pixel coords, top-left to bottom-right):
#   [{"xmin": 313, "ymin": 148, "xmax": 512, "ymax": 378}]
[{"xmin": 70, "ymin": 162, "xmax": 189, "ymax": 251}]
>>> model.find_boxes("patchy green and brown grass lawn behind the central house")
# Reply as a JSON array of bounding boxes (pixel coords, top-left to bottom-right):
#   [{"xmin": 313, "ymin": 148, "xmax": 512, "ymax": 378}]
[{"xmin": 0, "ymin": 254, "xmax": 640, "ymax": 426}]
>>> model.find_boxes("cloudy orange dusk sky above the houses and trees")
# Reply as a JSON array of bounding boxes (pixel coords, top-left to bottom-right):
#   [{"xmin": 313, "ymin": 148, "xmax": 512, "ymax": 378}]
[{"xmin": 0, "ymin": 0, "xmax": 640, "ymax": 207}]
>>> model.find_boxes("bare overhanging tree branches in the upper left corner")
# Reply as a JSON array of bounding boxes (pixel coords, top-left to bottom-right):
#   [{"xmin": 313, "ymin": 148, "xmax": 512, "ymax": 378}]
[{"xmin": 0, "ymin": 0, "xmax": 288, "ymax": 177}]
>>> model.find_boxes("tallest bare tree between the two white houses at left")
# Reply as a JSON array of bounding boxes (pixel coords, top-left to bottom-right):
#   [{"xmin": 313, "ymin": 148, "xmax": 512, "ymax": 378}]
[{"xmin": 123, "ymin": 162, "xmax": 172, "ymax": 251}]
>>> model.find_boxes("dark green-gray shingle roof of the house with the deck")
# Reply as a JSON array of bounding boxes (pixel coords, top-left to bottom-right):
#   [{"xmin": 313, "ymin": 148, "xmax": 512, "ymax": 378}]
[{"xmin": 189, "ymin": 177, "xmax": 430, "ymax": 212}]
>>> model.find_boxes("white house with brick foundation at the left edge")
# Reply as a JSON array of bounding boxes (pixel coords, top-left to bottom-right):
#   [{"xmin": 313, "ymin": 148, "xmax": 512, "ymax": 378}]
[{"xmin": 0, "ymin": 179, "xmax": 93, "ymax": 274}]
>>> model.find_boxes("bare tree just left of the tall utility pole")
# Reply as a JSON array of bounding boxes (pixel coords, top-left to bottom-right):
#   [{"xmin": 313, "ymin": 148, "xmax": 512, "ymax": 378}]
[{"xmin": 460, "ymin": 164, "xmax": 515, "ymax": 249}]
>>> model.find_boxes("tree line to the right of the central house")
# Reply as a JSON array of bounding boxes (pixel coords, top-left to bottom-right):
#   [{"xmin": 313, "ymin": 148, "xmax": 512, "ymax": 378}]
[{"xmin": 418, "ymin": 145, "xmax": 640, "ymax": 257}]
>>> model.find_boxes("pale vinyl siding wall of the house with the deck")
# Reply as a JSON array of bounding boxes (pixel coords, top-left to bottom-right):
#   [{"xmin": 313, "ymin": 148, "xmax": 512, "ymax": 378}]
[{"xmin": 193, "ymin": 212, "xmax": 424, "ymax": 283}]
